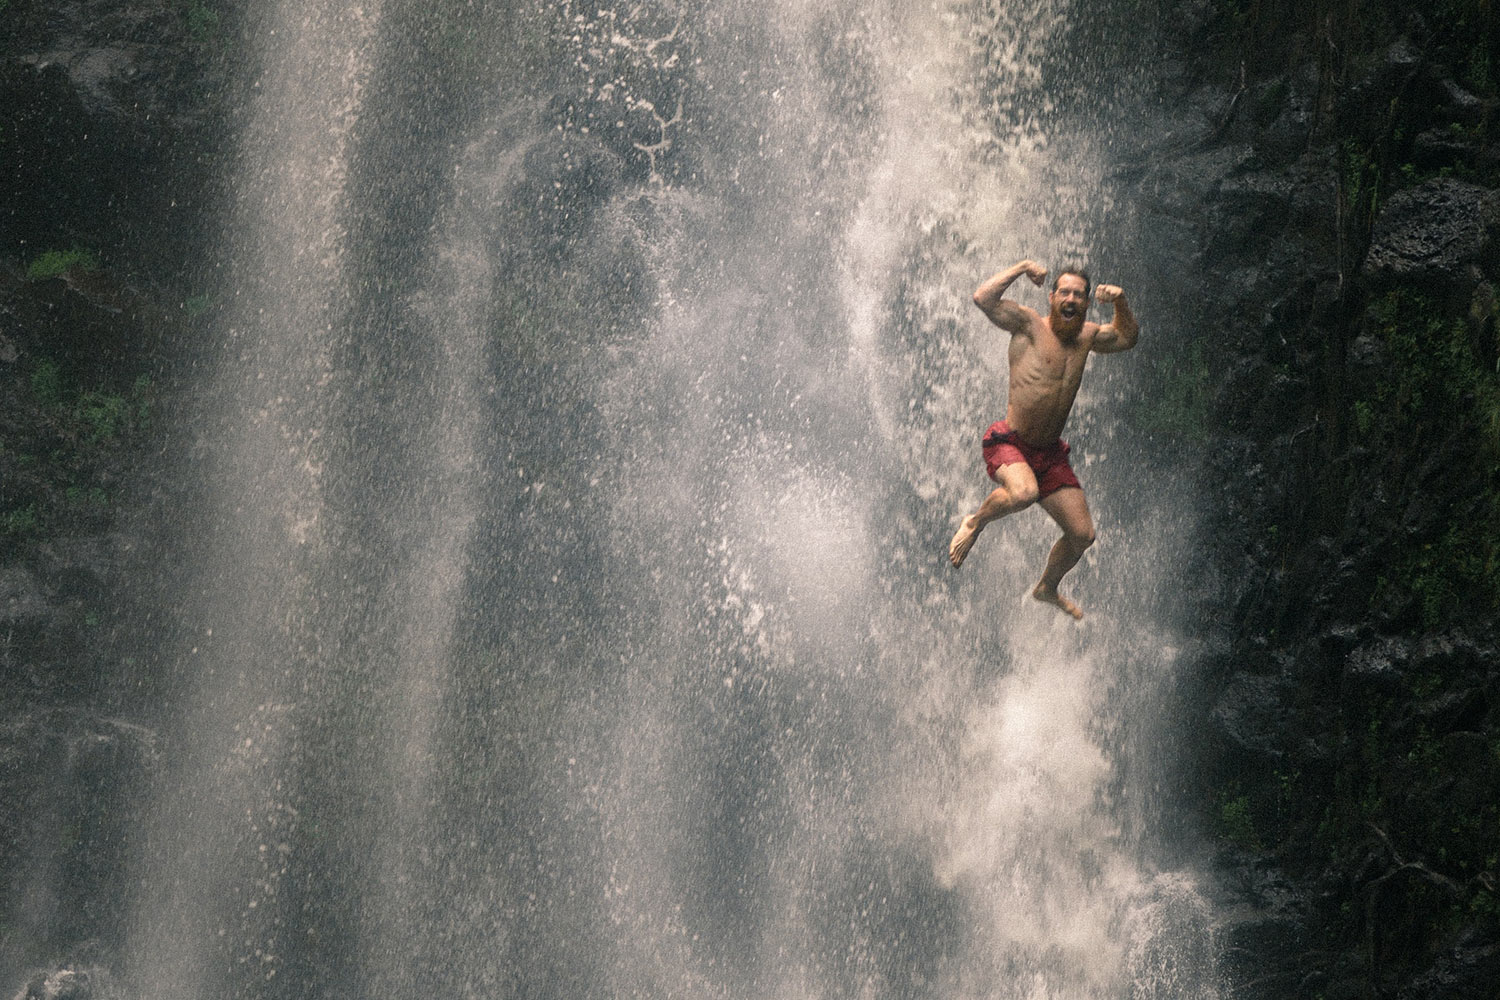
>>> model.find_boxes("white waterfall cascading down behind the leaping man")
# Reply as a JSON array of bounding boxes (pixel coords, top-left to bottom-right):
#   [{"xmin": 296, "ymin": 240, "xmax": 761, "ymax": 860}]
[{"xmin": 117, "ymin": 0, "xmax": 1217, "ymax": 1000}]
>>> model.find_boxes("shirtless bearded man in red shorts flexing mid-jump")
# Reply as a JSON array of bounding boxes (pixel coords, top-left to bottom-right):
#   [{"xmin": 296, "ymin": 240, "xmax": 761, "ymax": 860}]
[{"xmin": 948, "ymin": 261, "xmax": 1140, "ymax": 618}]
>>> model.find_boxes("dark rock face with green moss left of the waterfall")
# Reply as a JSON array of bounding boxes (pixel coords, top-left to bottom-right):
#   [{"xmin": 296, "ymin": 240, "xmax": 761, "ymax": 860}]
[{"xmin": 0, "ymin": 0, "xmax": 217, "ymax": 997}]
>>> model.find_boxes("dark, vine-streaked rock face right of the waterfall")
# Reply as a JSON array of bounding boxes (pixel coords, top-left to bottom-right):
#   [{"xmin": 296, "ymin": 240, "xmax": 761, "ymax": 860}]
[{"xmin": 1122, "ymin": 4, "xmax": 1500, "ymax": 1000}]
